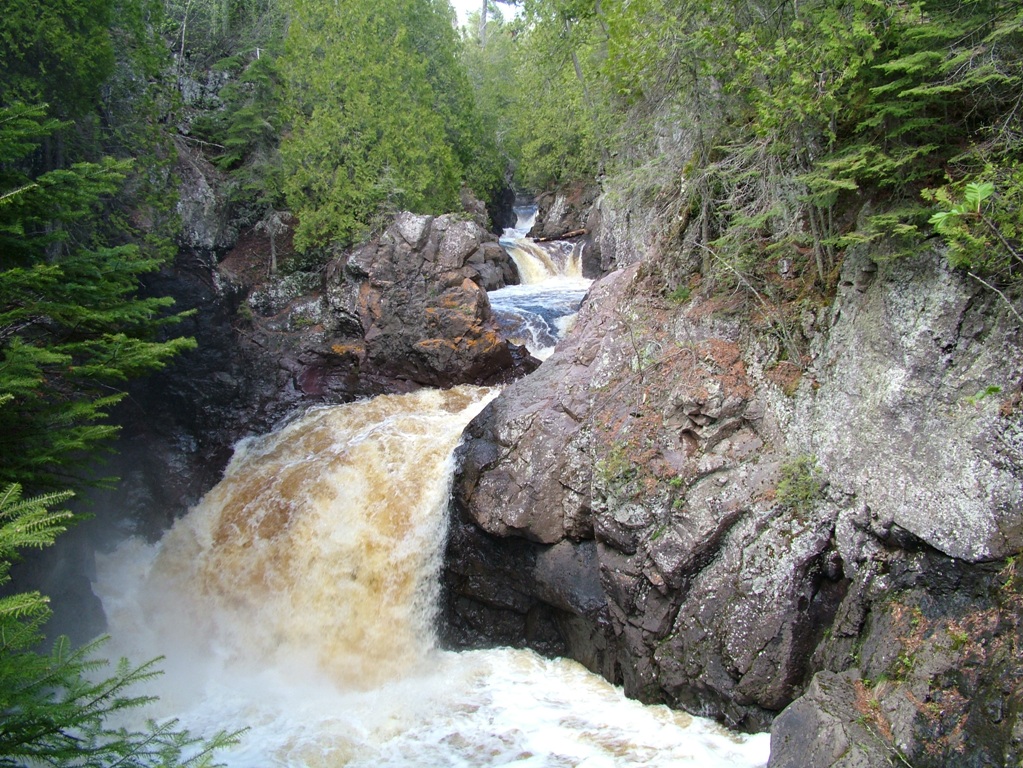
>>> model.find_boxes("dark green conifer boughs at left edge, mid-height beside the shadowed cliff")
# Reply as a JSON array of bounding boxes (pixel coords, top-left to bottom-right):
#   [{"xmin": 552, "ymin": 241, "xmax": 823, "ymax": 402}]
[{"xmin": 0, "ymin": 106, "xmax": 194, "ymax": 488}]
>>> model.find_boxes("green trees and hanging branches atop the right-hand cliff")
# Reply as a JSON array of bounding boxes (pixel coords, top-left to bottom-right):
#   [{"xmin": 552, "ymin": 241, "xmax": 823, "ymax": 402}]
[{"xmin": 513, "ymin": 0, "xmax": 1023, "ymax": 292}]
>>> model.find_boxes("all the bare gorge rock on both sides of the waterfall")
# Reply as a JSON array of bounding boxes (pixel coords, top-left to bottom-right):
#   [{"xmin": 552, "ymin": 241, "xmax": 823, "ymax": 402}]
[{"xmin": 72, "ymin": 145, "xmax": 1023, "ymax": 768}]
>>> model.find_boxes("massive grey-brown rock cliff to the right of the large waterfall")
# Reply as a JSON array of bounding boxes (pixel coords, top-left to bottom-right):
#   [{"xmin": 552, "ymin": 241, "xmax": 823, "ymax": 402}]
[{"xmin": 445, "ymin": 237, "xmax": 1023, "ymax": 752}]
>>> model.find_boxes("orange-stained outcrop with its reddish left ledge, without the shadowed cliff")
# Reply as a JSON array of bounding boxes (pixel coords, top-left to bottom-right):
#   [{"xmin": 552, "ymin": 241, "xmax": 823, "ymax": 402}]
[{"xmin": 229, "ymin": 213, "xmax": 533, "ymax": 414}]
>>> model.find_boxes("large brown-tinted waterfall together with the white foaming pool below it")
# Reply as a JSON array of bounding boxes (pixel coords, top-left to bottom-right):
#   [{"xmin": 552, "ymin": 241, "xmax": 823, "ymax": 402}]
[{"xmin": 96, "ymin": 388, "xmax": 767, "ymax": 768}]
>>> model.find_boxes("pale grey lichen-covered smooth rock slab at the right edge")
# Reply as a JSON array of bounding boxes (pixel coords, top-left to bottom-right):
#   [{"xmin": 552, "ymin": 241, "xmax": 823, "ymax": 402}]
[{"xmin": 792, "ymin": 249, "xmax": 1023, "ymax": 562}]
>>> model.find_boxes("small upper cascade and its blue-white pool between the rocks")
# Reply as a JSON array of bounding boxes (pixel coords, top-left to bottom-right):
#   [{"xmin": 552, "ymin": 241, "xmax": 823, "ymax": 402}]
[{"xmin": 488, "ymin": 206, "xmax": 591, "ymax": 360}]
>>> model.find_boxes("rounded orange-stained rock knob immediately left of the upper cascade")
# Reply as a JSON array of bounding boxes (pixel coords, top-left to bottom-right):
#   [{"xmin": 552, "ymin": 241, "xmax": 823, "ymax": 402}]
[{"xmin": 322, "ymin": 213, "xmax": 524, "ymax": 387}]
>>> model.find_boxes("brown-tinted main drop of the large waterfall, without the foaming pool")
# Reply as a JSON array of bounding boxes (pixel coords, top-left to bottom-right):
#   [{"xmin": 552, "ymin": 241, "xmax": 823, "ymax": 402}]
[{"xmin": 98, "ymin": 388, "xmax": 496, "ymax": 688}]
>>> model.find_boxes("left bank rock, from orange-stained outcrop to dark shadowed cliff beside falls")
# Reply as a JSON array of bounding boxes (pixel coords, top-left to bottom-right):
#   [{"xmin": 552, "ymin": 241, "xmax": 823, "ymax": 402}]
[{"xmin": 108, "ymin": 214, "xmax": 535, "ymax": 535}]
